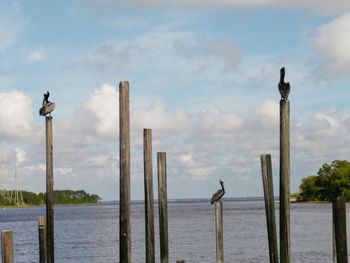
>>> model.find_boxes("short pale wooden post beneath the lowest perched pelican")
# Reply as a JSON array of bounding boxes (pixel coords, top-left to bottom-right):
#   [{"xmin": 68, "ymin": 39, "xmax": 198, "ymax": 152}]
[{"xmin": 215, "ymin": 201, "xmax": 224, "ymax": 263}]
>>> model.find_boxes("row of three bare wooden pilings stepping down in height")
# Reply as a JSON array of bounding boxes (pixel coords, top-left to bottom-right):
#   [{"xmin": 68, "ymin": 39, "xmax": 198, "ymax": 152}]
[{"xmin": 119, "ymin": 81, "xmax": 178, "ymax": 263}]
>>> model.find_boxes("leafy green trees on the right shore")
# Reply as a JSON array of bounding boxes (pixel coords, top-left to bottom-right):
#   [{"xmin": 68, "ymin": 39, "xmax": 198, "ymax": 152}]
[{"xmin": 298, "ymin": 160, "xmax": 350, "ymax": 201}]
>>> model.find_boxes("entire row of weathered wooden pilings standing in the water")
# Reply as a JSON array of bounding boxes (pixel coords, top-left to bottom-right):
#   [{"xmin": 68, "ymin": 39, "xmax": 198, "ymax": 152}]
[{"xmin": 1, "ymin": 75, "xmax": 348, "ymax": 263}]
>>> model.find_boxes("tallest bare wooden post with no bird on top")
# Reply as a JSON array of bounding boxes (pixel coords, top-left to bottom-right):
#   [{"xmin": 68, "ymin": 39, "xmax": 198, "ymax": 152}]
[{"xmin": 119, "ymin": 81, "xmax": 131, "ymax": 263}]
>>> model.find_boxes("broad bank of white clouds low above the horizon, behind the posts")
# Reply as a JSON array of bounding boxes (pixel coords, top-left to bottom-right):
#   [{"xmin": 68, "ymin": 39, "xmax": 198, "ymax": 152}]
[{"xmin": 0, "ymin": 84, "xmax": 350, "ymax": 198}]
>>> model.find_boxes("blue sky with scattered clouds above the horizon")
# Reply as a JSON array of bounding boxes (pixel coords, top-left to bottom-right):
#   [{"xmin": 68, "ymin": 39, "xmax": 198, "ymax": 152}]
[{"xmin": 0, "ymin": 0, "xmax": 350, "ymax": 200}]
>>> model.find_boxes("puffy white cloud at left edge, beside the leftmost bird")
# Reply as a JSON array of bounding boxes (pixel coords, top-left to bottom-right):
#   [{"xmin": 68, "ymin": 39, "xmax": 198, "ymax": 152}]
[{"xmin": 0, "ymin": 90, "xmax": 34, "ymax": 139}]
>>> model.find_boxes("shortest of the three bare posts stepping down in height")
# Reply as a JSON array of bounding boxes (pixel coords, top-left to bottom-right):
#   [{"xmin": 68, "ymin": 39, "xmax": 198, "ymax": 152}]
[{"xmin": 157, "ymin": 152, "xmax": 169, "ymax": 263}]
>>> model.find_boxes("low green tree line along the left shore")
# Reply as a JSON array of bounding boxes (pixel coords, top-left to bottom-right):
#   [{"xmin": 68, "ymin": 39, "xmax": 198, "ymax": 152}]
[{"xmin": 0, "ymin": 190, "xmax": 102, "ymax": 206}]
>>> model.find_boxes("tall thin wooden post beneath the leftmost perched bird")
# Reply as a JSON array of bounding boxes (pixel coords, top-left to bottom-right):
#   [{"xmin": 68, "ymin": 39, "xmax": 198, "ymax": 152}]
[{"xmin": 45, "ymin": 116, "xmax": 55, "ymax": 263}]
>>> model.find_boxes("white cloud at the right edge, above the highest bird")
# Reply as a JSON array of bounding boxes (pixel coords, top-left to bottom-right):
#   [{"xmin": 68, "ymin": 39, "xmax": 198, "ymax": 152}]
[{"xmin": 314, "ymin": 12, "xmax": 350, "ymax": 73}]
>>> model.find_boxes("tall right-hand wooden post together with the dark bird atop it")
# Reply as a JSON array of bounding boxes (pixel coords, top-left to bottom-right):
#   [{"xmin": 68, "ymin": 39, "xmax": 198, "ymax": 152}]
[{"xmin": 278, "ymin": 68, "xmax": 290, "ymax": 263}]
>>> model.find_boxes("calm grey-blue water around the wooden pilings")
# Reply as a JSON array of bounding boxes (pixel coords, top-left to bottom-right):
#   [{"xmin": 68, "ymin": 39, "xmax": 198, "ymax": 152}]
[{"xmin": 0, "ymin": 201, "xmax": 344, "ymax": 263}]
